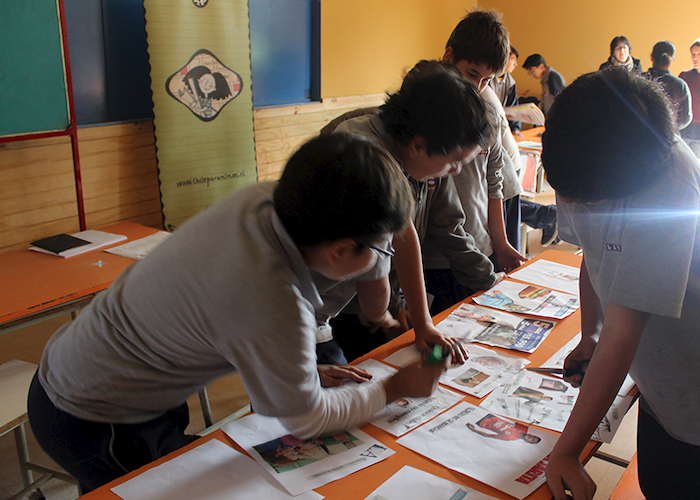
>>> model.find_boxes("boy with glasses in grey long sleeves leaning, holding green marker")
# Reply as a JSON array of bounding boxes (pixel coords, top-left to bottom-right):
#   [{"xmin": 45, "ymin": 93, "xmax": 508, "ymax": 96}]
[{"xmin": 28, "ymin": 134, "xmax": 445, "ymax": 492}]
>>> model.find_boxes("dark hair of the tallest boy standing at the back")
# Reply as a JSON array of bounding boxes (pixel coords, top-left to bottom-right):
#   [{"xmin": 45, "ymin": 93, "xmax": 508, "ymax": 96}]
[{"xmin": 445, "ymin": 10, "xmax": 510, "ymax": 75}]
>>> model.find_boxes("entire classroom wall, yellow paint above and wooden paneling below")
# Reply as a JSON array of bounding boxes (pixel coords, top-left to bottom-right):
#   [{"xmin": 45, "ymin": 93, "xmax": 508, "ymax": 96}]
[{"xmin": 6, "ymin": 0, "xmax": 700, "ymax": 251}]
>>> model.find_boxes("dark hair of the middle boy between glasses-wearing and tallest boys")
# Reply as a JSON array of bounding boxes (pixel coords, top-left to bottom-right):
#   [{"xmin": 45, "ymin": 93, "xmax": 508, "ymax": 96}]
[{"xmin": 379, "ymin": 61, "xmax": 493, "ymax": 155}]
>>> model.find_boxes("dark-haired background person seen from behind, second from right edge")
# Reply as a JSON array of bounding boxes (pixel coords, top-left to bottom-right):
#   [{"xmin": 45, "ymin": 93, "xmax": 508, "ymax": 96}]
[{"xmin": 644, "ymin": 40, "xmax": 693, "ymax": 130}]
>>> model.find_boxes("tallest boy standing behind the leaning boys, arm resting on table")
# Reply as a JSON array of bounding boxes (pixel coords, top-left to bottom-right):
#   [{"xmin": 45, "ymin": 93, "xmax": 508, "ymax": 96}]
[{"xmin": 423, "ymin": 11, "xmax": 525, "ymax": 312}]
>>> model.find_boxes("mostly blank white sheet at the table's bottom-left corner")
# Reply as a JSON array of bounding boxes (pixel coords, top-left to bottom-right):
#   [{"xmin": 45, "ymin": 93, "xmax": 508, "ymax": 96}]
[{"xmin": 112, "ymin": 439, "xmax": 323, "ymax": 500}]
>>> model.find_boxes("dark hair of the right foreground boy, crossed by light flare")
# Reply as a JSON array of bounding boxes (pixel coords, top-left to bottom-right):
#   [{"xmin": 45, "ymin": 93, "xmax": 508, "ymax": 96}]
[{"xmin": 542, "ymin": 68, "xmax": 675, "ymax": 202}]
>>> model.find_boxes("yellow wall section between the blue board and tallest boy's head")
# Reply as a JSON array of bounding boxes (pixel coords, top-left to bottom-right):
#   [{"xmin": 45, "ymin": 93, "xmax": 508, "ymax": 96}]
[{"xmin": 321, "ymin": 0, "xmax": 476, "ymax": 98}]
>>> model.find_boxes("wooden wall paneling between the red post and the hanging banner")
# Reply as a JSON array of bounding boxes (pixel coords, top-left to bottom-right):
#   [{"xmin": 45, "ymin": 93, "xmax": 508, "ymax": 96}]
[{"xmin": 78, "ymin": 122, "xmax": 162, "ymax": 228}]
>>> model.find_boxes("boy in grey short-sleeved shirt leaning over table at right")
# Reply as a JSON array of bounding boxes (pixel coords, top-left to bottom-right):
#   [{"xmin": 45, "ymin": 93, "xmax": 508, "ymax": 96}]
[{"xmin": 542, "ymin": 69, "xmax": 700, "ymax": 500}]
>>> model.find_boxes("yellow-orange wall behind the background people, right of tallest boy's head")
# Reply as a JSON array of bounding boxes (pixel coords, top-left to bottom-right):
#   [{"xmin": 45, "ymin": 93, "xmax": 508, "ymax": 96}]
[{"xmin": 479, "ymin": 0, "xmax": 700, "ymax": 95}]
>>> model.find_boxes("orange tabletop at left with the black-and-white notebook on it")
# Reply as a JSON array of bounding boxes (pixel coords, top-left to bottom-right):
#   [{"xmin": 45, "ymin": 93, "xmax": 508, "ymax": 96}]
[{"xmin": 0, "ymin": 222, "xmax": 157, "ymax": 328}]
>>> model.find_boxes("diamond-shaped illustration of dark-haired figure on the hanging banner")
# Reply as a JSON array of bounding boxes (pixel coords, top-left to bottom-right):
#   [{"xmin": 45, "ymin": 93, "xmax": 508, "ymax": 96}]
[{"xmin": 165, "ymin": 49, "xmax": 243, "ymax": 122}]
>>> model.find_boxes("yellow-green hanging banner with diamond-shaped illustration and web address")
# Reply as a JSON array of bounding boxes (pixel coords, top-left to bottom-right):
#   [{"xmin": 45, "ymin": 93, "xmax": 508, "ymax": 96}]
[{"xmin": 144, "ymin": 0, "xmax": 257, "ymax": 229}]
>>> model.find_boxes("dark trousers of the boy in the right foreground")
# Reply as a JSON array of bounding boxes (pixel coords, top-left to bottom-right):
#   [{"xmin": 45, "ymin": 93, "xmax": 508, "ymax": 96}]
[{"xmin": 637, "ymin": 408, "xmax": 700, "ymax": 500}]
